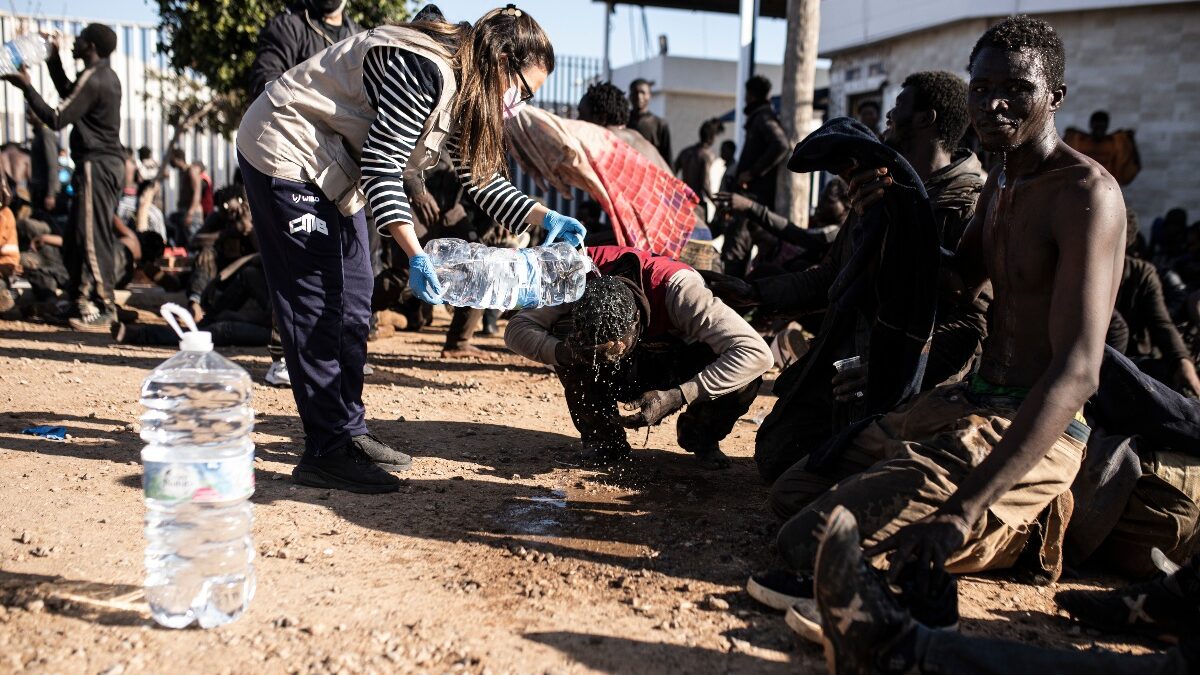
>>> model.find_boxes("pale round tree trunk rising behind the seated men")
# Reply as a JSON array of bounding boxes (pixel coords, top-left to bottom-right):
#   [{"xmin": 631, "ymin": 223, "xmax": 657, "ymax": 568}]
[{"xmin": 774, "ymin": 0, "xmax": 821, "ymax": 227}]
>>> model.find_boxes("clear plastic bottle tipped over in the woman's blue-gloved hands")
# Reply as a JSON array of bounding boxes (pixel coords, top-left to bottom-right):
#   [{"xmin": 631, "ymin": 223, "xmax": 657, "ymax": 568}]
[{"xmin": 425, "ymin": 239, "xmax": 594, "ymax": 310}]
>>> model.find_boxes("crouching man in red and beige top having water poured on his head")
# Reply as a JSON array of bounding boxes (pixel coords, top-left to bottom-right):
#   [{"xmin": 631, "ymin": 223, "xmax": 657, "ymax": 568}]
[{"xmin": 504, "ymin": 246, "xmax": 772, "ymax": 468}]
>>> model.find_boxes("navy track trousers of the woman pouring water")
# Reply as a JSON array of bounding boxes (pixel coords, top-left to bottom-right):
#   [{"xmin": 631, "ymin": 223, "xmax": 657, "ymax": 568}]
[{"xmin": 238, "ymin": 154, "xmax": 374, "ymax": 454}]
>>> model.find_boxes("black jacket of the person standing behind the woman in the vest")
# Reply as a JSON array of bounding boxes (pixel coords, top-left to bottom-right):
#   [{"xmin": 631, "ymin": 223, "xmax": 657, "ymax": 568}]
[{"xmin": 250, "ymin": 5, "xmax": 362, "ymax": 101}]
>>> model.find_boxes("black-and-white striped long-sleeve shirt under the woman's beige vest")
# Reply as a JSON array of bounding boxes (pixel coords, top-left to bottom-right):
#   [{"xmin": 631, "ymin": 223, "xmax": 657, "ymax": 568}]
[{"xmin": 361, "ymin": 47, "xmax": 535, "ymax": 233}]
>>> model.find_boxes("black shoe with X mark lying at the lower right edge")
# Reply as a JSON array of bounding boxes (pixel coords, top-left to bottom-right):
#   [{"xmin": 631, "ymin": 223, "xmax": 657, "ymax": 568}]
[{"xmin": 1055, "ymin": 559, "xmax": 1200, "ymax": 639}]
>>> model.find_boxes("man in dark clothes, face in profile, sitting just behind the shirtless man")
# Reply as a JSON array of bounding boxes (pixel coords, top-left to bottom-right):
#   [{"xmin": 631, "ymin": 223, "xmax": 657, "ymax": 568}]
[{"xmin": 713, "ymin": 71, "xmax": 989, "ymax": 480}]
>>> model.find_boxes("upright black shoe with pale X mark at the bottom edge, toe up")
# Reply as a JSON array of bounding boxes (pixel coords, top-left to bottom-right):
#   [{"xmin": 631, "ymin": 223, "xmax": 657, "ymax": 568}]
[{"xmin": 814, "ymin": 507, "xmax": 917, "ymax": 675}]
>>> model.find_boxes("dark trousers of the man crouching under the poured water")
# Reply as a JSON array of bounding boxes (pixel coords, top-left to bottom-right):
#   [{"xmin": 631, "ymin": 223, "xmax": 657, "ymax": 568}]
[{"xmin": 554, "ymin": 340, "xmax": 762, "ymax": 452}]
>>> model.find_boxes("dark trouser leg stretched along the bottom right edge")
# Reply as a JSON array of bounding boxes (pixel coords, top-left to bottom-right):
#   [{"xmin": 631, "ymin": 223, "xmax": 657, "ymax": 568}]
[{"xmin": 918, "ymin": 628, "xmax": 1185, "ymax": 675}]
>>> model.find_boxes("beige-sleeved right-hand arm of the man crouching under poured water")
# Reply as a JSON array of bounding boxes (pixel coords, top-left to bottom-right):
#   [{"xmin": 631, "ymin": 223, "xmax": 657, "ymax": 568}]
[{"xmin": 662, "ymin": 271, "xmax": 774, "ymax": 404}]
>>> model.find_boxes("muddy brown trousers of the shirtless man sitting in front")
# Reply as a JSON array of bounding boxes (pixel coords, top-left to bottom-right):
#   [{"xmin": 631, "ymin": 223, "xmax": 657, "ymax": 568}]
[{"xmin": 770, "ymin": 384, "xmax": 1091, "ymax": 580}]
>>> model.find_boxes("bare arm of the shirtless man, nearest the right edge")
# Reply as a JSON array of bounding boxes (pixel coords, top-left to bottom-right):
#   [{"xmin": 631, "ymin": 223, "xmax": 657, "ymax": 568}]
[{"xmin": 943, "ymin": 172, "xmax": 1126, "ymax": 525}]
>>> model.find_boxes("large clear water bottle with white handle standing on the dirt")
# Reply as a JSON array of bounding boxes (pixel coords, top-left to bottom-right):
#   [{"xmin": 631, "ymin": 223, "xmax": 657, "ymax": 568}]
[{"xmin": 142, "ymin": 304, "xmax": 254, "ymax": 628}]
